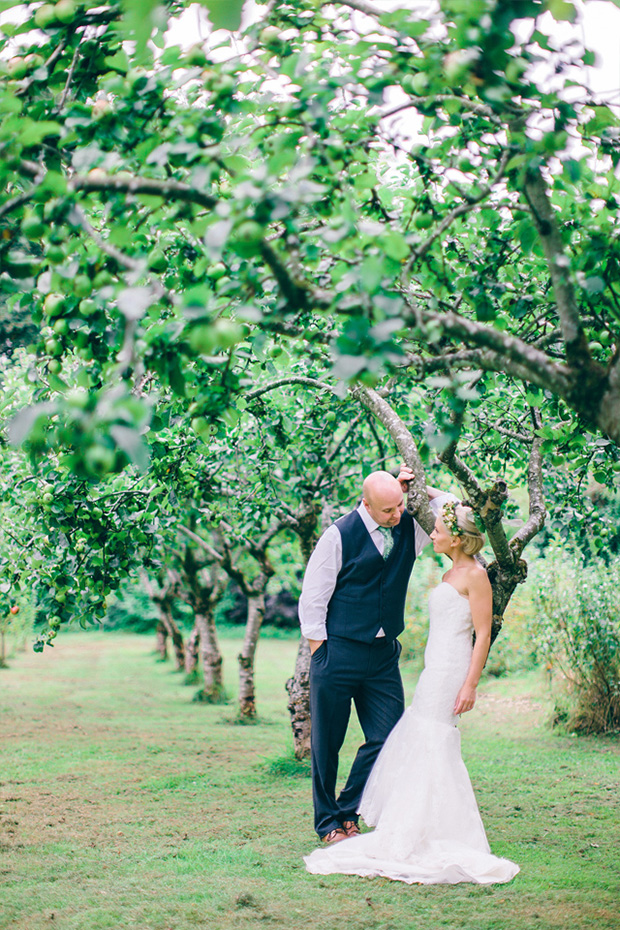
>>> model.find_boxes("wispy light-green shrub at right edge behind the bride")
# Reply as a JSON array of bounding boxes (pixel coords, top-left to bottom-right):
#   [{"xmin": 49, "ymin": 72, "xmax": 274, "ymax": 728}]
[{"xmin": 533, "ymin": 554, "xmax": 620, "ymax": 733}]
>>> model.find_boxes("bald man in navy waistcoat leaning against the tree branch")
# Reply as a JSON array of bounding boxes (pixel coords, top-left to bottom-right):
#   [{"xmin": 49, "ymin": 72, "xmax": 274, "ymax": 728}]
[{"xmin": 299, "ymin": 466, "xmax": 454, "ymax": 843}]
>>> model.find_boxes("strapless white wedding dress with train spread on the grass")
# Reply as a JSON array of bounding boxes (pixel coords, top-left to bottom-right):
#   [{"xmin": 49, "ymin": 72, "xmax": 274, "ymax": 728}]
[{"xmin": 305, "ymin": 581, "xmax": 519, "ymax": 884}]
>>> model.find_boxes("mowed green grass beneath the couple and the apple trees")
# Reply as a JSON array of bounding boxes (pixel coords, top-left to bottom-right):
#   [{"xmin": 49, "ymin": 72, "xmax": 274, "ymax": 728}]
[{"xmin": 0, "ymin": 633, "xmax": 620, "ymax": 930}]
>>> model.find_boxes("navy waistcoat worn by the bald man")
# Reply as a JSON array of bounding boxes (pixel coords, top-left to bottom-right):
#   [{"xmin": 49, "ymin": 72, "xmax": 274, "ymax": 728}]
[{"xmin": 327, "ymin": 510, "xmax": 415, "ymax": 643}]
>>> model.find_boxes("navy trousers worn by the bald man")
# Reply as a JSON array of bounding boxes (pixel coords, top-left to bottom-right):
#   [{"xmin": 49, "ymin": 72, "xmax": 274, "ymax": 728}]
[{"xmin": 310, "ymin": 636, "xmax": 405, "ymax": 837}]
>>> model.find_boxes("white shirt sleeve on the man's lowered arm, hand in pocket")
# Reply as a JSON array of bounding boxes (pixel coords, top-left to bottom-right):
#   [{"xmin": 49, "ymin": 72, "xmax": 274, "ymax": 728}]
[{"xmin": 299, "ymin": 525, "xmax": 342, "ymax": 639}]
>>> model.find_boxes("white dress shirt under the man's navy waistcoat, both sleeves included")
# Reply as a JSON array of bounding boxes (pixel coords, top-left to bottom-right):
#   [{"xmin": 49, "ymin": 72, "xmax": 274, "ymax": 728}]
[{"xmin": 299, "ymin": 494, "xmax": 458, "ymax": 640}]
